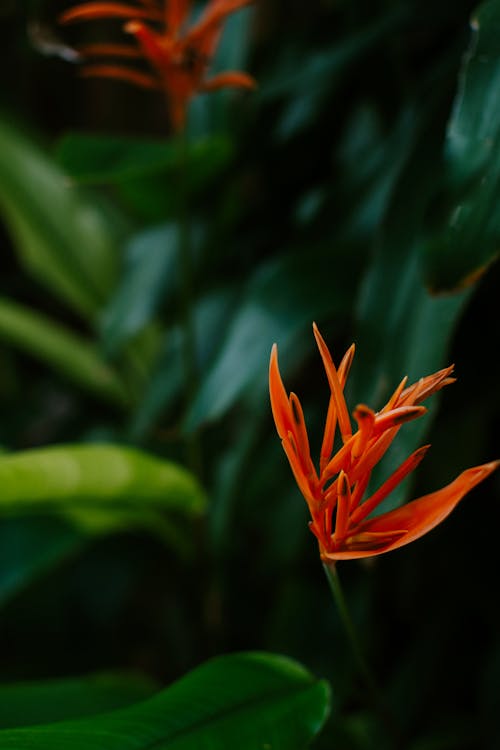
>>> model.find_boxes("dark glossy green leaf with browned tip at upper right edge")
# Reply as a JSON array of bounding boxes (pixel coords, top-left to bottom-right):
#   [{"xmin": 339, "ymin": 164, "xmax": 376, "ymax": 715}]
[{"xmin": 425, "ymin": 0, "xmax": 500, "ymax": 290}]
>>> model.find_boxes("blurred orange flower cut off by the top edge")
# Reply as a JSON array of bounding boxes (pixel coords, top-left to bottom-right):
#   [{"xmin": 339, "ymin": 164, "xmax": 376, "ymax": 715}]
[{"xmin": 60, "ymin": 0, "xmax": 256, "ymax": 130}]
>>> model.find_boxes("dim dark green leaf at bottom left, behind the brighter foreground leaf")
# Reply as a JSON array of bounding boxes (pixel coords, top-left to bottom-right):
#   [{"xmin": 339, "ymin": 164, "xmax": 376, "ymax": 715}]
[{"xmin": 0, "ymin": 672, "xmax": 155, "ymax": 729}]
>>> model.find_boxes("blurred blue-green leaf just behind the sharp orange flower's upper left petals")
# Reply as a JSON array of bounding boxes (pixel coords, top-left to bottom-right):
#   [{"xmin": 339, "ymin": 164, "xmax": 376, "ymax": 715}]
[{"xmin": 184, "ymin": 251, "xmax": 353, "ymax": 431}]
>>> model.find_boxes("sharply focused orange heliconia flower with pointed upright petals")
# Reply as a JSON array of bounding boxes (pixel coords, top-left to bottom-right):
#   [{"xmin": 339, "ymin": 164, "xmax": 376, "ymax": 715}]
[{"xmin": 269, "ymin": 325, "xmax": 500, "ymax": 562}]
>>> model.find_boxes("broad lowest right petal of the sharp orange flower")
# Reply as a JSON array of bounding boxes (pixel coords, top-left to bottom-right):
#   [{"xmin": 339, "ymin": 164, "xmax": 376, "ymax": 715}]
[{"xmin": 358, "ymin": 461, "xmax": 500, "ymax": 554}]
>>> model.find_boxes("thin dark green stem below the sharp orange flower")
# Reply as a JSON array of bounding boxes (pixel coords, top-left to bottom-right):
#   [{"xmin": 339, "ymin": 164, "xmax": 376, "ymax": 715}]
[{"xmin": 323, "ymin": 562, "xmax": 401, "ymax": 748}]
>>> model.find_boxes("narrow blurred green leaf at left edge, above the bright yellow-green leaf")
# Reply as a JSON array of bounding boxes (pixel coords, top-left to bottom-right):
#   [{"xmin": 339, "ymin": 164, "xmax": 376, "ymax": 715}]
[{"xmin": 0, "ymin": 298, "xmax": 128, "ymax": 405}]
